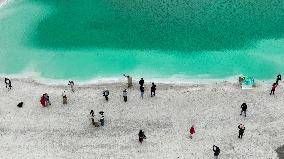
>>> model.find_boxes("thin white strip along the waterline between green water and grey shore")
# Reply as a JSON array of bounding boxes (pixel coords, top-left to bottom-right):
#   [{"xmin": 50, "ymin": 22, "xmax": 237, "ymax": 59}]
[{"xmin": 0, "ymin": 72, "xmax": 274, "ymax": 86}]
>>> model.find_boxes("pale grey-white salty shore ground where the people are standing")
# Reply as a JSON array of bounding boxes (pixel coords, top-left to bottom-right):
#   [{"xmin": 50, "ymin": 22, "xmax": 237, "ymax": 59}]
[{"xmin": 0, "ymin": 78, "xmax": 284, "ymax": 159}]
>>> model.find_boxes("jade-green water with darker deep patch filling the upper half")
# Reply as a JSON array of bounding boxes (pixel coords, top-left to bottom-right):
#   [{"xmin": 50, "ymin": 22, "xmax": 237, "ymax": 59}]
[{"xmin": 0, "ymin": 0, "xmax": 284, "ymax": 80}]
